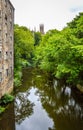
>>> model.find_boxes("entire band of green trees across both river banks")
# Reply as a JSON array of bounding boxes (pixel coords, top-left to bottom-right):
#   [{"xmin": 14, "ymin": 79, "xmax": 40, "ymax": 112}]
[{"xmin": 15, "ymin": 13, "xmax": 83, "ymax": 86}]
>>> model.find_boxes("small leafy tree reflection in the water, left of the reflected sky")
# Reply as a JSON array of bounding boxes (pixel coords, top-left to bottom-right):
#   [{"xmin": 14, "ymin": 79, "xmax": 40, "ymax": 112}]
[{"xmin": 15, "ymin": 92, "xmax": 34, "ymax": 124}]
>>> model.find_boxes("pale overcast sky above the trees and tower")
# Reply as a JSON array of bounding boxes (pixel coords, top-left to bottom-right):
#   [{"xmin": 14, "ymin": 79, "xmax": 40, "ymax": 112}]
[{"xmin": 10, "ymin": 0, "xmax": 83, "ymax": 32}]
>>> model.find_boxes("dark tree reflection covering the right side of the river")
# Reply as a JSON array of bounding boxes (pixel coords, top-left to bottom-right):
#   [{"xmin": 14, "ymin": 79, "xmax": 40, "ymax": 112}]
[{"xmin": 35, "ymin": 72, "xmax": 83, "ymax": 130}]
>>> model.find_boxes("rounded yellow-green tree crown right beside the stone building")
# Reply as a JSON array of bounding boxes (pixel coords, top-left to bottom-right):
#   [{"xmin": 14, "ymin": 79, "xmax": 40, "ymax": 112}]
[{"xmin": 14, "ymin": 25, "xmax": 34, "ymax": 65}]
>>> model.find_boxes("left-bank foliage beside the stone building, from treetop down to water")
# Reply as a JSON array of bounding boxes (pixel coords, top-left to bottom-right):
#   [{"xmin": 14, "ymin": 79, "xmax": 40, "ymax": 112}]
[{"xmin": 14, "ymin": 25, "xmax": 34, "ymax": 86}]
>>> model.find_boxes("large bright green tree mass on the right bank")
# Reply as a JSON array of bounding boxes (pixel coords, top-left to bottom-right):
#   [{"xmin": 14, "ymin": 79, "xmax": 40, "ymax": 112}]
[{"xmin": 34, "ymin": 13, "xmax": 83, "ymax": 85}]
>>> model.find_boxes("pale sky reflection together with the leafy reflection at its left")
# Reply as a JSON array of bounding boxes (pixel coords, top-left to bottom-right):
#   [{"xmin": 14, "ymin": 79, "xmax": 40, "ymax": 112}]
[{"xmin": 15, "ymin": 87, "xmax": 53, "ymax": 130}]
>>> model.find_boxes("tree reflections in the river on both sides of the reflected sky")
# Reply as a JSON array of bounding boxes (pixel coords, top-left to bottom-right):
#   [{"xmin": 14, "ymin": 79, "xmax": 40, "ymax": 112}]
[{"xmin": 15, "ymin": 70, "xmax": 83, "ymax": 130}]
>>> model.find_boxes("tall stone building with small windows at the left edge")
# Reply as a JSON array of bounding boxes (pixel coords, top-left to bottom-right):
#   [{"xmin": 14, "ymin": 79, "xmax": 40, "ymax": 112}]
[{"xmin": 0, "ymin": 0, "xmax": 14, "ymax": 98}]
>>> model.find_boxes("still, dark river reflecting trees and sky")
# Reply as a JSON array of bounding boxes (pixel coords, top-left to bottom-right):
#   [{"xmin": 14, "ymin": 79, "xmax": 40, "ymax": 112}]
[{"xmin": 0, "ymin": 69, "xmax": 83, "ymax": 130}]
